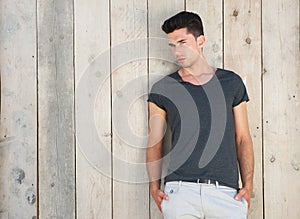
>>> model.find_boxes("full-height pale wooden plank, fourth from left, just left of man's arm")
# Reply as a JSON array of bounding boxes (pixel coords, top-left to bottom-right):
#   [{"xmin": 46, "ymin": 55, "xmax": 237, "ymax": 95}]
[{"xmin": 111, "ymin": 0, "xmax": 149, "ymax": 219}]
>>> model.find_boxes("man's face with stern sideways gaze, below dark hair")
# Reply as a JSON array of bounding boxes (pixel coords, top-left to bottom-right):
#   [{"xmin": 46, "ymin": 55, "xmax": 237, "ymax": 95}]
[{"xmin": 168, "ymin": 28, "xmax": 201, "ymax": 68}]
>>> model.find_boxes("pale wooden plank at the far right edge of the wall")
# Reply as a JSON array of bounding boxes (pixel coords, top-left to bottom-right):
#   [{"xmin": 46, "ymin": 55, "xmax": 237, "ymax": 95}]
[{"xmin": 262, "ymin": 0, "xmax": 300, "ymax": 219}]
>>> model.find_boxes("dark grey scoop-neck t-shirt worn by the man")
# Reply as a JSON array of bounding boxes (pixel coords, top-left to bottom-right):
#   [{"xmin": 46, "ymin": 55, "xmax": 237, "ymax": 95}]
[{"xmin": 148, "ymin": 69, "xmax": 249, "ymax": 188}]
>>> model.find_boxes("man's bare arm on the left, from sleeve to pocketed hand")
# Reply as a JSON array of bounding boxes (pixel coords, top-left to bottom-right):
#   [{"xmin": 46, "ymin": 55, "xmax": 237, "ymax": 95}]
[{"xmin": 146, "ymin": 102, "xmax": 168, "ymax": 211}]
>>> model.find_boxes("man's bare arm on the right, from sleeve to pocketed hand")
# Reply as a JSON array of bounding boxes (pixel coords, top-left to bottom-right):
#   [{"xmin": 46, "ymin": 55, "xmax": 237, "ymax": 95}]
[{"xmin": 233, "ymin": 102, "xmax": 254, "ymax": 207}]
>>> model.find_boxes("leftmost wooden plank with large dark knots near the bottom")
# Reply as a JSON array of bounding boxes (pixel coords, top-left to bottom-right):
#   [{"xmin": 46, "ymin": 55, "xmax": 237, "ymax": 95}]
[{"xmin": 0, "ymin": 0, "xmax": 37, "ymax": 219}]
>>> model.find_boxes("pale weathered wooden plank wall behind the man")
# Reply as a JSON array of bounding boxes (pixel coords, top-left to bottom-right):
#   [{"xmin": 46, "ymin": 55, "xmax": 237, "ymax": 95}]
[{"xmin": 0, "ymin": 0, "xmax": 300, "ymax": 219}]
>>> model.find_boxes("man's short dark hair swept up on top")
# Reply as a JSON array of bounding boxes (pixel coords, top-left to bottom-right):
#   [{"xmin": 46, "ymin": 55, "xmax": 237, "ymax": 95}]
[{"xmin": 161, "ymin": 11, "xmax": 204, "ymax": 38}]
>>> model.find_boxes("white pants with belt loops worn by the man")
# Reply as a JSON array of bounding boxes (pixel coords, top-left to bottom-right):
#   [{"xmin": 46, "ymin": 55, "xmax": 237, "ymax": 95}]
[{"xmin": 161, "ymin": 181, "xmax": 248, "ymax": 219}]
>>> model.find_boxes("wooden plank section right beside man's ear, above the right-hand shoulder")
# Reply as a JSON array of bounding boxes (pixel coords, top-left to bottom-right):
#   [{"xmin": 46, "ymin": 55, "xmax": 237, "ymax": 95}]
[{"xmin": 186, "ymin": 0, "xmax": 223, "ymax": 68}]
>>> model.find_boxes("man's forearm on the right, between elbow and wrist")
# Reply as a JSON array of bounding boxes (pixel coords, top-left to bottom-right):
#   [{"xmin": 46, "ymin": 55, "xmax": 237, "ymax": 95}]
[{"xmin": 237, "ymin": 136, "xmax": 254, "ymax": 192}]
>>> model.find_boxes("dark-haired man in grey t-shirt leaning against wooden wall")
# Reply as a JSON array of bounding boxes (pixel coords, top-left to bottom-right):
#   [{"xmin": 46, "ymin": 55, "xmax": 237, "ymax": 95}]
[{"xmin": 147, "ymin": 11, "xmax": 254, "ymax": 219}]
